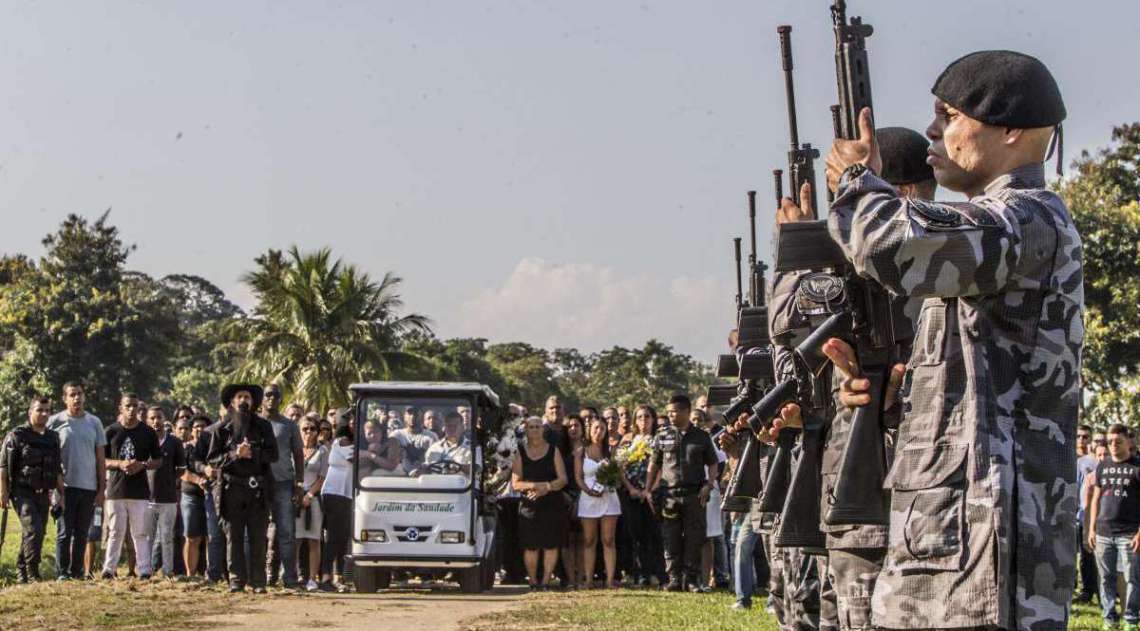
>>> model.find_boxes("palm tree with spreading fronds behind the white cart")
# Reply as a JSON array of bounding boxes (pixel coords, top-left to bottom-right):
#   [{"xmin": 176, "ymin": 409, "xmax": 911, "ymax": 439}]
[{"xmin": 235, "ymin": 246, "xmax": 431, "ymax": 411}]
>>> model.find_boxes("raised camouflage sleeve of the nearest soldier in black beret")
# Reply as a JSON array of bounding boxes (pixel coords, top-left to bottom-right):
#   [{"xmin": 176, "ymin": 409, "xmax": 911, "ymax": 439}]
[{"xmin": 828, "ymin": 172, "xmax": 1020, "ymax": 297}]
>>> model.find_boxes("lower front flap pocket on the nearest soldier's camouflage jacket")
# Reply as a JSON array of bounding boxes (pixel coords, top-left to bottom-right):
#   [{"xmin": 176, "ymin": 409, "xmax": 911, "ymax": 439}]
[{"xmin": 887, "ymin": 444, "xmax": 969, "ymax": 572}]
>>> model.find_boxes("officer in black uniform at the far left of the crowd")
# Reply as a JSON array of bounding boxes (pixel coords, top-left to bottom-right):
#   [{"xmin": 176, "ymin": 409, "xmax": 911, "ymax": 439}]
[{"xmin": 0, "ymin": 398, "xmax": 64, "ymax": 583}]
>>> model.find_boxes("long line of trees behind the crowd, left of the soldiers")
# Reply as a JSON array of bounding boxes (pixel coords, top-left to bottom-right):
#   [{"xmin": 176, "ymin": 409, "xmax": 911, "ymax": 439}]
[{"xmin": 0, "ymin": 212, "xmax": 711, "ymax": 428}]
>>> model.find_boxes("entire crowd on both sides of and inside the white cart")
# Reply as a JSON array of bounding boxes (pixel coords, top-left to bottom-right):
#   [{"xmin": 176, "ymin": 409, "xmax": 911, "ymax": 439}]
[{"xmin": 0, "ymin": 383, "xmax": 766, "ymax": 592}]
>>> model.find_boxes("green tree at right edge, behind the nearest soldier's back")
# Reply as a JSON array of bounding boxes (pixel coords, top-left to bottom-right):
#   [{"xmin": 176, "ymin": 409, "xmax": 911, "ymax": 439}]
[{"xmin": 1058, "ymin": 123, "xmax": 1140, "ymax": 425}]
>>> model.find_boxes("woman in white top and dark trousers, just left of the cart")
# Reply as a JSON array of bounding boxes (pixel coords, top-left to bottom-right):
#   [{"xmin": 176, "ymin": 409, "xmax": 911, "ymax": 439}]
[{"xmin": 320, "ymin": 425, "xmax": 352, "ymax": 592}]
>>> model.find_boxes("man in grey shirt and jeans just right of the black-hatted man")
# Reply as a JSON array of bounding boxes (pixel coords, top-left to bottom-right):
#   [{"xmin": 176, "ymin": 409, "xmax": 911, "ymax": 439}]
[{"xmin": 262, "ymin": 384, "xmax": 304, "ymax": 589}]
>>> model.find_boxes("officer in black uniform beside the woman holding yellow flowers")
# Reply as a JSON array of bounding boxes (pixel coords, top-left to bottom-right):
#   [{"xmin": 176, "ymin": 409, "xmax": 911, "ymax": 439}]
[{"xmin": 646, "ymin": 394, "xmax": 717, "ymax": 591}]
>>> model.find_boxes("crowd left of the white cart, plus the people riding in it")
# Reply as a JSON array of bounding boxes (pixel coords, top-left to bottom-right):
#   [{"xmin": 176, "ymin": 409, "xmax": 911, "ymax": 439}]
[{"xmin": 0, "ymin": 383, "xmax": 471, "ymax": 592}]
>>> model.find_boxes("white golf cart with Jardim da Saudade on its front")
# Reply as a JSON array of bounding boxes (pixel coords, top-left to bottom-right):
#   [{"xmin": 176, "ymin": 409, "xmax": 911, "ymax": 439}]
[{"xmin": 350, "ymin": 382, "xmax": 500, "ymax": 593}]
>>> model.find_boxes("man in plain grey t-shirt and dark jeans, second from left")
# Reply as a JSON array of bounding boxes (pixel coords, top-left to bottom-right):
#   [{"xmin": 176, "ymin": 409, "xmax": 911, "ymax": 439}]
[{"xmin": 48, "ymin": 383, "xmax": 107, "ymax": 580}]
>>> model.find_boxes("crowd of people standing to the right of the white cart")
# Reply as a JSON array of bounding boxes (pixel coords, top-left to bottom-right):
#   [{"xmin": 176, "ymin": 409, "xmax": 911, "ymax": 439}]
[{"xmin": 499, "ymin": 394, "xmax": 768, "ymax": 598}]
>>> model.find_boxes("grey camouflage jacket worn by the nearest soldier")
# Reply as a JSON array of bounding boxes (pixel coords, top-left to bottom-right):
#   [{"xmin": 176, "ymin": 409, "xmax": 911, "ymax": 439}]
[{"xmin": 829, "ymin": 164, "xmax": 1084, "ymax": 630}]
